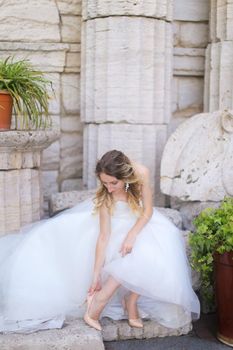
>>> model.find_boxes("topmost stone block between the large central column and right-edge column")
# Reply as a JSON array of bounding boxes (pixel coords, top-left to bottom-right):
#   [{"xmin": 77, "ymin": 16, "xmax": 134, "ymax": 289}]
[{"xmin": 173, "ymin": 0, "xmax": 209, "ymax": 21}]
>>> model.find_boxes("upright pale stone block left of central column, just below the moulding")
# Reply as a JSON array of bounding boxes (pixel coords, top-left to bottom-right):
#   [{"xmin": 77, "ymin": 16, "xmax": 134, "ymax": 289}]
[{"xmin": 61, "ymin": 73, "xmax": 80, "ymax": 114}]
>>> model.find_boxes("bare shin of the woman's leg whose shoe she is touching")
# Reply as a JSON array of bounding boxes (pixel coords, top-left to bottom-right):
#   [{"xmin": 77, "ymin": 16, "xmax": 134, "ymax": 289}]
[{"xmin": 89, "ymin": 276, "xmax": 120, "ymax": 320}]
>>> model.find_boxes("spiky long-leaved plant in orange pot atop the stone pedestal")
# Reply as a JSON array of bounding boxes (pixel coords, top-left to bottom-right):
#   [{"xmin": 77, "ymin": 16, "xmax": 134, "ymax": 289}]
[{"xmin": 0, "ymin": 56, "xmax": 51, "ymax": 129}]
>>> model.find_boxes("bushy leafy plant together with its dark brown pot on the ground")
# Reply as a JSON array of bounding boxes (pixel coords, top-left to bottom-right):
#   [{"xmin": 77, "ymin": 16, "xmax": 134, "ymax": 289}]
[{"xmin": 189, "ymin": 197, "xmax": 233, "ymax": 346}]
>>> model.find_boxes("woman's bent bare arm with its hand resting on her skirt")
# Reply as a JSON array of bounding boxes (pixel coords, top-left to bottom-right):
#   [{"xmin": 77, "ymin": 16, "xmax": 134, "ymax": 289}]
[{"xmin": 120, "ymin": 167, "xmax": 153, "ymax": 256}]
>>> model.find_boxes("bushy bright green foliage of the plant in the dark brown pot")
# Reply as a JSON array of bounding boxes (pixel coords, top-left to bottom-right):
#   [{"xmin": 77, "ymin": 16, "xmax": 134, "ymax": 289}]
[{"xmin": 189, "ymin": 197, "xmax": 233, "ymax": 308}]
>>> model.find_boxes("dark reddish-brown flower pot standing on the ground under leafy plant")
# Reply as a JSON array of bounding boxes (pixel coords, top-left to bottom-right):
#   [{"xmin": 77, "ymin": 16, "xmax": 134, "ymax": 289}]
[{"xmin": 214, "ymin": 252, "xmax": 233, "ymax": 347}]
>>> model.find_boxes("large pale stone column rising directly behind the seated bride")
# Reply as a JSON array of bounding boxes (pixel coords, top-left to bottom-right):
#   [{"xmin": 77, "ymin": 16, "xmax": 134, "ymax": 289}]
[{"xmin": 81, "ymin": 0, "xmax": 172, "ymax": 205}]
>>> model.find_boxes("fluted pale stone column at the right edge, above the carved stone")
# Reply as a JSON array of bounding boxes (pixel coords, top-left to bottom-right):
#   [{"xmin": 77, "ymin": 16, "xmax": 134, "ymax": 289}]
[{"xmin": 204, "ymin": 0, "xmax": 233, "ymax": 112}]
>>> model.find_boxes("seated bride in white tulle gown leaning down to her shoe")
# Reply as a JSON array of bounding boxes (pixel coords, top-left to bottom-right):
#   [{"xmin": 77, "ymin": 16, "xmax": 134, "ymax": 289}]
[{"xmin": 0, "ymin": 150, "xmax": 200, "ymax": 332}]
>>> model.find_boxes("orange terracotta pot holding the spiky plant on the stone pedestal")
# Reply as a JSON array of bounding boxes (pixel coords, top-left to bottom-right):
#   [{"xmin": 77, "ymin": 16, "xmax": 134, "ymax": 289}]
[{"xmin": 0, "ymin": 90, "xmax": 13, "ymax": 130}]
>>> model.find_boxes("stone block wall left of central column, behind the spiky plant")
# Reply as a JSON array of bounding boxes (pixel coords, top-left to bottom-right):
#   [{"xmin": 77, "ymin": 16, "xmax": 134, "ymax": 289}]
[{"xmin": 0, "ymin": 0, "xmax": 82, "ymax": 212}]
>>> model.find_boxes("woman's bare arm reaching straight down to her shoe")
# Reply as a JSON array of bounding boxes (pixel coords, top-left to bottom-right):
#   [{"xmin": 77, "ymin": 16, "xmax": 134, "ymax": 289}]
[{"xmin": 89, "ymin": 206, "xmax": 111, "ymax": 293}]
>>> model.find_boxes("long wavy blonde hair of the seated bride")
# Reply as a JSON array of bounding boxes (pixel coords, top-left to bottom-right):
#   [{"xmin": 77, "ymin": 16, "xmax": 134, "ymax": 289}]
[{"xmin": 94, "ymin": 150, "xmax": 143, "ymax": 216}]
